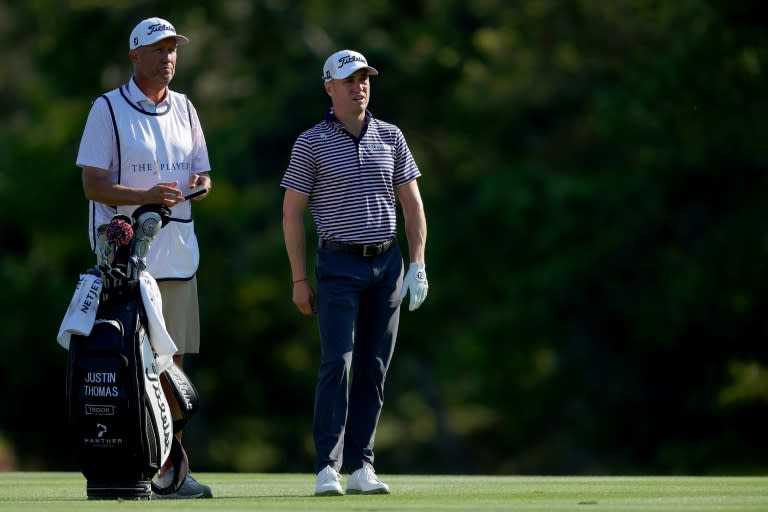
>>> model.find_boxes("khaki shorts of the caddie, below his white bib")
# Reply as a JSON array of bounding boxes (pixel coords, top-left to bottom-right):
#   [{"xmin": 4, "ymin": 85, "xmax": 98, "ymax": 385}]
[{"xmin": 157, "ymin": 277, "xmax": 200, "ymax": 355}]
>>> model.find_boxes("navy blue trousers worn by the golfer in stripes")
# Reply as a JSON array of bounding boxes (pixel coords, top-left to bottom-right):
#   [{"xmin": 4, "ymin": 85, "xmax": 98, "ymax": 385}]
[{"xmin": 313, "ymin": 244, "xmax": 403, "ymax": 473}]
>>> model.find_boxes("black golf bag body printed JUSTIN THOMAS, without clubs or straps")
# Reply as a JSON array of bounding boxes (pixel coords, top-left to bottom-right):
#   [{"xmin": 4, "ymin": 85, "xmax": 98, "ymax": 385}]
[{"xmin": 67, "ymin": 282, "xmax": 173, "ymax": 499}]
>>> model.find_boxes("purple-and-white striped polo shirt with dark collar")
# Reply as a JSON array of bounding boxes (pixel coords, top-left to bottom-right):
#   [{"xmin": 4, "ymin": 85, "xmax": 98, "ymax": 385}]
[{"xmin": 280, "ymin": 109, "xmax": 421, "ymax": 243}]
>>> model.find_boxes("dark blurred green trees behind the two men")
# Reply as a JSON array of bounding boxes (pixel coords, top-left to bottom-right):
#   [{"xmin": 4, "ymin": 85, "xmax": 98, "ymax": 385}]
[{"xmin": 0, "ymin": 0, "xmax": 768, "ymax": 474}]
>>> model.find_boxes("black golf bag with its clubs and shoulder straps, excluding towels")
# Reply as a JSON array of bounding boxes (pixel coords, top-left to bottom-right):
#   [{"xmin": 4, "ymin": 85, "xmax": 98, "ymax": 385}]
[{"xmin": 66, "ymin": 205, "xmax": 197, "ymax": 499}]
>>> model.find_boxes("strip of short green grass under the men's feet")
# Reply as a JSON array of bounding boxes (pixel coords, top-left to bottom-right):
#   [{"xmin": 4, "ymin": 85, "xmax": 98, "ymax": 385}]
[{"xmin": 0, "ymin": 472, "xmax": 768, "ymax": 512}]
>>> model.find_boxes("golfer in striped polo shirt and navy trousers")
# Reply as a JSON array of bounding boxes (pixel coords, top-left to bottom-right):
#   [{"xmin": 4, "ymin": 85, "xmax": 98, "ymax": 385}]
[{"xmin": 280, "ymin": 50, "xmax": 427, "ymax": 496}]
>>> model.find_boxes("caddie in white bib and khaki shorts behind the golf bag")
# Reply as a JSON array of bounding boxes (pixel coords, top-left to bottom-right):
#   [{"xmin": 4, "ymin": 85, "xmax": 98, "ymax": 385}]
[{"xmin": 77, "ymin": 18, "xmax": 212, "ymax": 498}]
